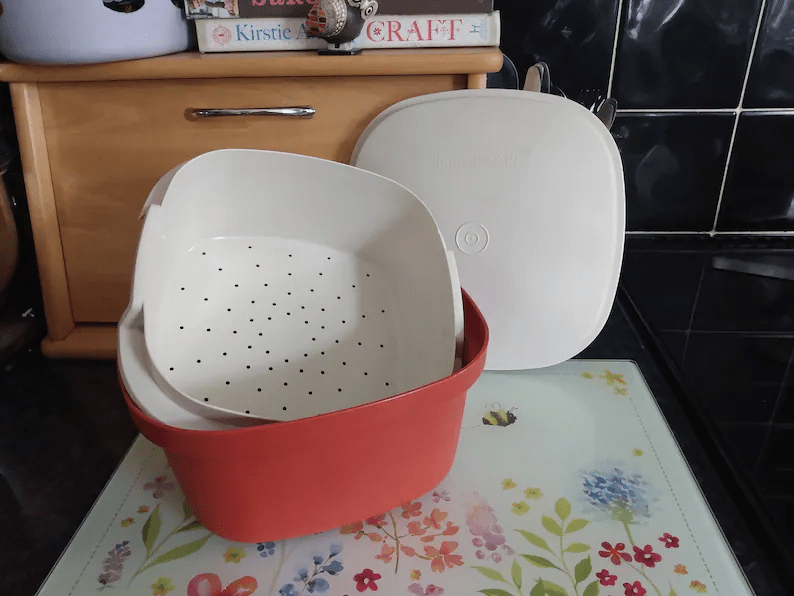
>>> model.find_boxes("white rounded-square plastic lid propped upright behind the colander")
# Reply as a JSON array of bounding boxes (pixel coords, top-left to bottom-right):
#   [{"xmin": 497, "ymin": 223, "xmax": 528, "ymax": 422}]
[{"xmin": 351, "ymin": 89, "xmax": 625, "ymax": 369}]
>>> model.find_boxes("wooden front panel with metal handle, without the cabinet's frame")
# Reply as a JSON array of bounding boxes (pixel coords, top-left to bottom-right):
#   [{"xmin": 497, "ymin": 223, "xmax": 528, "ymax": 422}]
[{"xmin": 40, "ymin": 75, "xmax": 467, "ymax": 323}]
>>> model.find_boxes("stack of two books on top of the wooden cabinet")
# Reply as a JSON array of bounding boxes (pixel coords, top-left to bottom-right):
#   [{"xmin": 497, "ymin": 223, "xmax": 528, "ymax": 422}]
[{"xmin": 185, "ymin": 0, "xmax": 500, "ymax": 52}]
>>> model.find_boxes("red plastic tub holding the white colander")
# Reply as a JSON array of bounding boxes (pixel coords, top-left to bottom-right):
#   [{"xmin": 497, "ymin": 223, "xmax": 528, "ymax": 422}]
[{"xmin": 122, "ymin": 292, "xmax": 488, "ymax": 542}]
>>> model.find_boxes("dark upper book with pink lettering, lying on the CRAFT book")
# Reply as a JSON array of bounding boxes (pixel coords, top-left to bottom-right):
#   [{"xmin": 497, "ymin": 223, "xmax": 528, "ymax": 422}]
[{"xmin": 184, "ymin": 0, "xmax": 494, "ymax": 20}]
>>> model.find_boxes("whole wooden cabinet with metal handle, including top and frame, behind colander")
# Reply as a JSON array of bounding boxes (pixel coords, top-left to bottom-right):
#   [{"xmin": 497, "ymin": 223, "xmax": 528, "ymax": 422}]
[{"xmin": 0, "ymin": 48, "xmax": 502, "ymax": 358}]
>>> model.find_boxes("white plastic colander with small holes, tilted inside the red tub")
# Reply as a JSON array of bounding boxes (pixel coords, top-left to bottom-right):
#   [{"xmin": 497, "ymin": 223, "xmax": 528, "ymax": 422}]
[{"xmin": 119, "ymin": 149, "xmax": 463, "ymax": 425}]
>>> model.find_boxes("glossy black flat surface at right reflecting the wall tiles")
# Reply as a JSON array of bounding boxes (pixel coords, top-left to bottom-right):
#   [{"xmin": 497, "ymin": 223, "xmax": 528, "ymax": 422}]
[{"xmin": 622, "ymin": 234, "xmax": 794, "ymax": 552}]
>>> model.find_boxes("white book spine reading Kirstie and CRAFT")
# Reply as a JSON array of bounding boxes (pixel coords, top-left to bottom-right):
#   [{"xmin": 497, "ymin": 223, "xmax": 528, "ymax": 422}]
[{"xmin": 196, "ymin": 11, "xmax": 500, "ymax": 52}]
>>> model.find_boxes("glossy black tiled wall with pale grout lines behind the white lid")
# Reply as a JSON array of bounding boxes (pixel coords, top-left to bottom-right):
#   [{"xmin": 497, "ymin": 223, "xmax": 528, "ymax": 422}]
[{"xmin": 495, "ymin": 0, "xmax": 794, "ymax": 234}]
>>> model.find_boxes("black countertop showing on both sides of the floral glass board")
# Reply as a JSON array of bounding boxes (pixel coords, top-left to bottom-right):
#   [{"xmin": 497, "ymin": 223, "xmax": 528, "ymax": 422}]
[{"xmin": 0, "ymin": 292, "xmax": 794, "ymax": 596}]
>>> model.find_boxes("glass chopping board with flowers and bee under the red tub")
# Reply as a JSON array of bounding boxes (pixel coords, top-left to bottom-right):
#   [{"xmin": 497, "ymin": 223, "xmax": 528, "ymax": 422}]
[{"xmin": 39, "ymin": 361, "xmax": 752, "ymax": 596}]
